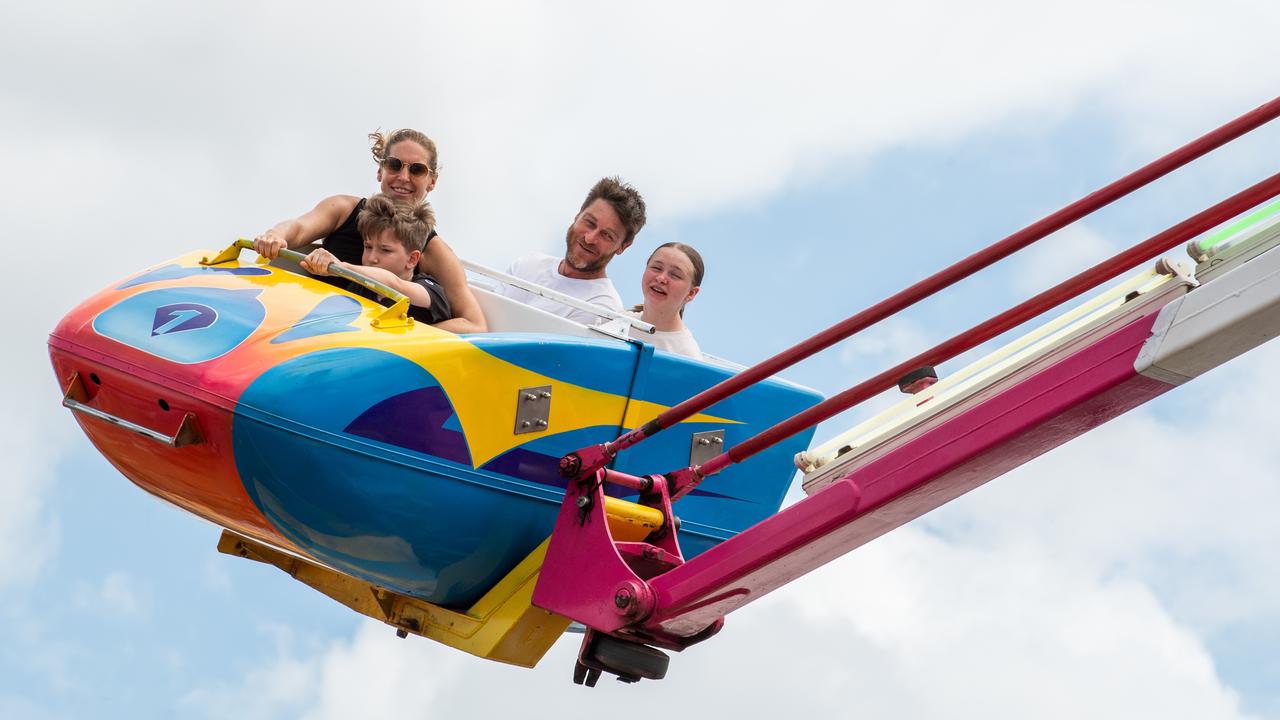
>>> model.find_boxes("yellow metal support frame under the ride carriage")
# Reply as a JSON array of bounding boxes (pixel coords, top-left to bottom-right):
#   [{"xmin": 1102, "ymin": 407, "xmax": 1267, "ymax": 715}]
[{"xmin": 218, "ymin": 497, "xmax": 662, "ymax": 667}]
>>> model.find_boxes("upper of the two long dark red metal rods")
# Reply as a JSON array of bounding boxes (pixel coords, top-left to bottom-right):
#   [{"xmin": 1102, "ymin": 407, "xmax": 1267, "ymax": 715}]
[{"xmin": 561, "ymin": 92, "xmax": 1280, "ymax": 478}]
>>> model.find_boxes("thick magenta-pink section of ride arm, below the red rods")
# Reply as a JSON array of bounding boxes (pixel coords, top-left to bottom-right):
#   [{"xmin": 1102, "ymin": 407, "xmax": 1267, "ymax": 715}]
[{"xmin": 641, "ymin": 309, "xmax": 1172, "ymax": 635}]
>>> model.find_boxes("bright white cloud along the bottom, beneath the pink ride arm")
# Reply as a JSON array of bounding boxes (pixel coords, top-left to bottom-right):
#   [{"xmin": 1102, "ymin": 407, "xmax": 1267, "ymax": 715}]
[{"xmin": 192, "ymin": 527, "xmax": 1243, "ymax": 719}]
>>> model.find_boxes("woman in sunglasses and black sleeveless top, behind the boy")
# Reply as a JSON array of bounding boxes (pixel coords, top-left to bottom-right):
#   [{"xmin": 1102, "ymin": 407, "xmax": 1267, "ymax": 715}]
[{"xmin": 253, "ymin": 128, "xmax": 488, "ymax": 333}]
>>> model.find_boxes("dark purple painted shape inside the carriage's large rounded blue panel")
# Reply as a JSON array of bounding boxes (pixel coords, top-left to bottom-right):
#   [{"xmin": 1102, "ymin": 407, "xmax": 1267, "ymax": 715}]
[{"xmin": 344, "ymin": 386, "xmax": 471, "ymax": 465}]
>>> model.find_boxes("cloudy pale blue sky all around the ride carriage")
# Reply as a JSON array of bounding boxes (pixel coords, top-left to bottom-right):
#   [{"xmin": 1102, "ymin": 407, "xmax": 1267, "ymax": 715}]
[{"xmin": 0, "ymin": 0, "xmax": 1280, "ymax": 719}]
